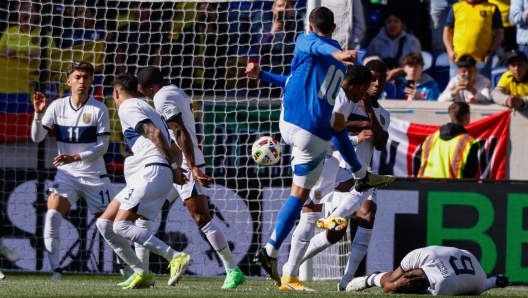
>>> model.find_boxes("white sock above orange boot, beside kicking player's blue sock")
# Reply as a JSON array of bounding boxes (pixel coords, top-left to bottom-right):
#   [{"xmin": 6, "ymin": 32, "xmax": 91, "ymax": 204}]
[{"xmin": 282, "ymin": 212, "xmax": 321, "ymax": 277}]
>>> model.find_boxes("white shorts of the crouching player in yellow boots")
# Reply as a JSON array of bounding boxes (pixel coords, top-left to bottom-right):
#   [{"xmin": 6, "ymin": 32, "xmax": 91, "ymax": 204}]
[{"xmin": 116, "ymin": 165, "xmax": 172, "ymax": 220}]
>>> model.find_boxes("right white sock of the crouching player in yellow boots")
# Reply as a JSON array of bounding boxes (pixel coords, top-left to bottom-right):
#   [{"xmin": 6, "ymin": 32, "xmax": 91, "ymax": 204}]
[{"xmin": 114, "ymin": 220, "xmax": 180, "ymax": 262}]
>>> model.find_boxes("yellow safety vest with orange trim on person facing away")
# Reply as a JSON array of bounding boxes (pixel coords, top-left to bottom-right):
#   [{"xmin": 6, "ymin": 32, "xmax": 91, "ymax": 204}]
[{"xmin": 418, "ymin": 131, "xmax": 477, "ymax": 178}]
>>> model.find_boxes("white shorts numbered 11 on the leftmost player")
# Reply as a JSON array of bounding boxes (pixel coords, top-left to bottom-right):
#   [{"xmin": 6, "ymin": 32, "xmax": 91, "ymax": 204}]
[{"xmin": 47, "ymin": 171, "xmax": 115, "ymax": 214}]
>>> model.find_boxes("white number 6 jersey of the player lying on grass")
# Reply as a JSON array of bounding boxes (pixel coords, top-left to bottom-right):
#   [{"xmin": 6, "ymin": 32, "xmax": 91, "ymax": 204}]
[{"xmin": 400, "ymin": 246, "xmax": 487, "ymax": 296}]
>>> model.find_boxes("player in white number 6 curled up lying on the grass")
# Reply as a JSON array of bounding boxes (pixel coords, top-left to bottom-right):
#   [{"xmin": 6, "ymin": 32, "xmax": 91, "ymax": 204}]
[{"xmin": 346, "ymin": 246, "xmax": 508, "ymax": 296}]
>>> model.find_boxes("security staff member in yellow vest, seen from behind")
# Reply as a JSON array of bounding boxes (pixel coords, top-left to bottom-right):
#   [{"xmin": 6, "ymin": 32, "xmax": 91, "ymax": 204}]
[{"xmin": 418, "ymin": 102, "xmax": 479, "ymax": 179}]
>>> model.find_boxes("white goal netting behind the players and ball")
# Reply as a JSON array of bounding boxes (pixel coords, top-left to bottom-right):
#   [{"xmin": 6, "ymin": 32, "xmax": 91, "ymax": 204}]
[{"xmin": 0, "ymin": 0, "xmax": 352, "ymax": 278}]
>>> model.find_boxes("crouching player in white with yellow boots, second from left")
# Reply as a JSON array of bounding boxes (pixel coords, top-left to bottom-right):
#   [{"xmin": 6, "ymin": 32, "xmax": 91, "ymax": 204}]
[{"xmin": 97, "ymin": 74, "xmax": 189, "ymax": 289}]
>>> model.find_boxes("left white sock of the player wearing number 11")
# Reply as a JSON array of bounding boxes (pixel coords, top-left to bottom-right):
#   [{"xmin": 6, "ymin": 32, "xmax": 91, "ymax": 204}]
[{"xmin": 44, "ymin": 209, "xmax": 62, "ymax": 270}]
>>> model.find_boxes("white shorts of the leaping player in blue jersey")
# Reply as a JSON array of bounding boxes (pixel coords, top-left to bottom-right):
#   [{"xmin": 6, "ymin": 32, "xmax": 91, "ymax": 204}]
[{"xmin": 279, "ymin": 114, "xmax": 328, "ymax": 189}]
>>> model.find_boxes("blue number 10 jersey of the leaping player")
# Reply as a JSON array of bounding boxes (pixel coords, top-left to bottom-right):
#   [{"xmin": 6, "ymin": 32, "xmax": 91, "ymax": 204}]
[{"xmin": 283, "ymin": 33, "xmax": 346, "ymax": 141}]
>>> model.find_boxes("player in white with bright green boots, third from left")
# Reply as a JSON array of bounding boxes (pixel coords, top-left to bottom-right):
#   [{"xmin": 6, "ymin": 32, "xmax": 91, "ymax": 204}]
[{"xmin": 138, "ymin": 66, "xmax": 246, "ymax": 289}]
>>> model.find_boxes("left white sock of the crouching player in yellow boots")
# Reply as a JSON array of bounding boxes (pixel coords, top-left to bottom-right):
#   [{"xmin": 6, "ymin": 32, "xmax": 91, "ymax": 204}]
[{"xmin": 96, "ymin": 218, "xmax": 149, "ymax": 274}]
